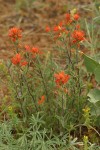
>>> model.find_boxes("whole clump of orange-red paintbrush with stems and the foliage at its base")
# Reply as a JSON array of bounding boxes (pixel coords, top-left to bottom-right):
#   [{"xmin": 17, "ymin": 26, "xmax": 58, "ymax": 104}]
[{"xmin": 0, "ymin": 12, "xmax": 100, "ymax": 150}]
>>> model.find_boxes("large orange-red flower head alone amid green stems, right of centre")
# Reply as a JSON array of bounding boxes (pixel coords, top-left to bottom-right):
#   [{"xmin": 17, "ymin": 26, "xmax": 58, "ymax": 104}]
[{"xmin": 54, "ymin": 71, "xmax": 70, "ymax": 86}]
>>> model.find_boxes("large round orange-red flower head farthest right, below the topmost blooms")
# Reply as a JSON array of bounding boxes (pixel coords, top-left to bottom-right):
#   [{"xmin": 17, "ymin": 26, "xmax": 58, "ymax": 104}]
[{"xmin": 72, "ymin": 30, "xmax": 85, "ymax": 43}]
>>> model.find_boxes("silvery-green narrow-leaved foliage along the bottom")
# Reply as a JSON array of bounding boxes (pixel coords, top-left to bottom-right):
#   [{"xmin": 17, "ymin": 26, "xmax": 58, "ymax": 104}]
[{"xmin": 0, "ymin": 113, "xmax": 98, "ymax": 150}]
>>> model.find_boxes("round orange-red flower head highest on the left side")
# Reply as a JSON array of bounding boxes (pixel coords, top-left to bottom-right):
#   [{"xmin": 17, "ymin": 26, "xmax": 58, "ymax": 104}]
[{"xmin": 8, "ymin": 27, "xmax": 22, "ymax": 42}]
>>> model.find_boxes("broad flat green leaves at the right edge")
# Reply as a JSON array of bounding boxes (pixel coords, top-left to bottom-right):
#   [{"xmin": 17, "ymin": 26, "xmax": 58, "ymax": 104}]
[{"xmin": 84, "ymin": 55, "xmax": 100, "ymax": 126}]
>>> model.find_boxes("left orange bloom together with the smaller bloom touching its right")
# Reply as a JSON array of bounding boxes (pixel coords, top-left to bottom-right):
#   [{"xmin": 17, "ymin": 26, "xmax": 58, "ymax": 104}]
[{"xmin": 11, "ymin": 53, "xmax": 28, "ymax": 66}]
